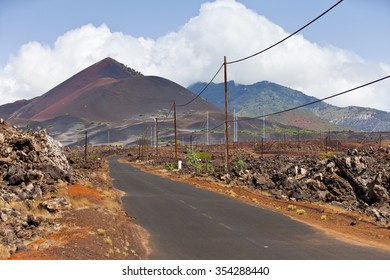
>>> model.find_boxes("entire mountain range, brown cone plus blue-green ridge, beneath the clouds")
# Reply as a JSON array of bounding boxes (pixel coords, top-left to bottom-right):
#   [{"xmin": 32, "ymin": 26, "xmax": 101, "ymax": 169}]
[{"xmin": 0, "ymin": 58, "xmax": 390, "ymax": 145}]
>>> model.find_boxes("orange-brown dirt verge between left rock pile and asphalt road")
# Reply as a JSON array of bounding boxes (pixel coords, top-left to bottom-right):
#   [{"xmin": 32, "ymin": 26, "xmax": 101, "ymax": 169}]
[{"xmin": 10, "ymin": 160, "xmax": 149, "ymax": 260}]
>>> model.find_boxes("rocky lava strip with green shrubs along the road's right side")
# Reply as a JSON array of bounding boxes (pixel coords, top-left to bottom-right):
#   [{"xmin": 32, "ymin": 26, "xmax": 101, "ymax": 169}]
[{"xmin": 142, "ymin": 142, "xmax": 390, "ymax": 227}]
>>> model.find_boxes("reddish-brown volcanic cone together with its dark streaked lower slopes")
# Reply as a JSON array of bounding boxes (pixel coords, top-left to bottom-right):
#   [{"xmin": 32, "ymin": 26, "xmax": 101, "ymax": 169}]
[{"xmin": 0, "ymin": 58, "xmax": 224, "ymax": 145}]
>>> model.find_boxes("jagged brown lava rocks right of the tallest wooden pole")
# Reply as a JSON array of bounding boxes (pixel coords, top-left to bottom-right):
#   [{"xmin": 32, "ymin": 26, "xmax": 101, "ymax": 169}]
[{"xmin": 225, "ymin": 147, "xmax": 390, "ymax": 226}]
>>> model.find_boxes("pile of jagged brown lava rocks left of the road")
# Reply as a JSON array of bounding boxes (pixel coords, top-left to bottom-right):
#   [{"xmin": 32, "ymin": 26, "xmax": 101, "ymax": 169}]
[{"xmin": 0, "ymin": 120, "xmax": 70, "ymax": 258}]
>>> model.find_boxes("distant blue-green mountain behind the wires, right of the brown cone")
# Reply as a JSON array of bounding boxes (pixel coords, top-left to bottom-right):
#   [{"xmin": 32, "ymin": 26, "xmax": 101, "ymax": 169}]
[{"xmin": 188, "ymin": 81, "xmax": 390, "ymax": 131}]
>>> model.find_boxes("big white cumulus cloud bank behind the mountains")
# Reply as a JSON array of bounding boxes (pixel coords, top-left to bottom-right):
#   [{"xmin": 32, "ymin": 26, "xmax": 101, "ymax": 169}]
[{"xmin": 0, "ymin": 0, "xmax": 390, "ymax": 111}]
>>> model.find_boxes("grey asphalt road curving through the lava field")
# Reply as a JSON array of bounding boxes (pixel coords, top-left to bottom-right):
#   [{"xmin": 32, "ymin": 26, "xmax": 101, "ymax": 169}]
[{"xmin": 109, "ymin": 158, "xmax": 390, "ymax": 260}]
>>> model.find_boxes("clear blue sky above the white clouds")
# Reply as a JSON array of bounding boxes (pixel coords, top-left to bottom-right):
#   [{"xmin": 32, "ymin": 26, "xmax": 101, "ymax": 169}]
[{"xmin": 0, "ymin": 0, "xmax": 390, "ymax": 65}]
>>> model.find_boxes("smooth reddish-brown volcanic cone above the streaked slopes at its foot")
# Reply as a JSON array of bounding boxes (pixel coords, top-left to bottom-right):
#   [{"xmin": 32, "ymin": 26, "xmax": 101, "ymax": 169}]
[{"xmin": 8, "ymin": 58, "xmax": 220, "ymax": 122}]
